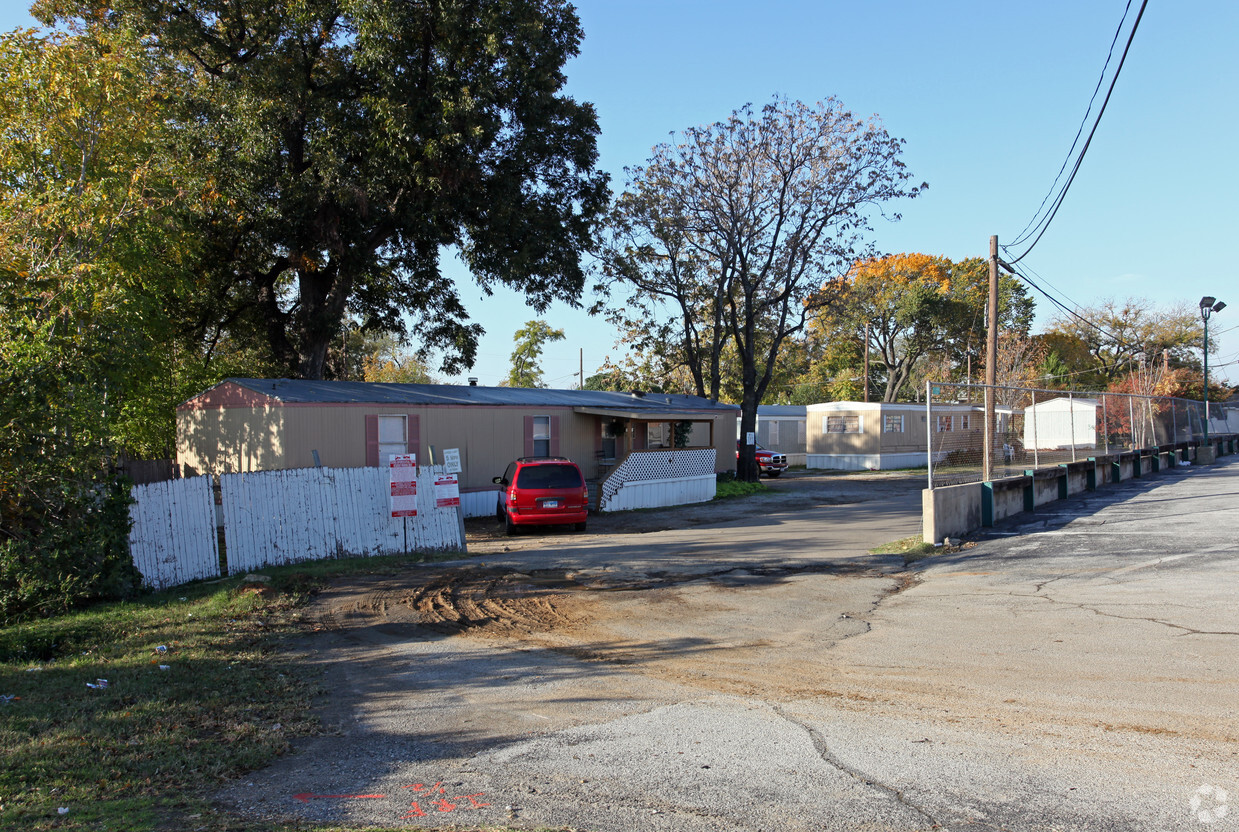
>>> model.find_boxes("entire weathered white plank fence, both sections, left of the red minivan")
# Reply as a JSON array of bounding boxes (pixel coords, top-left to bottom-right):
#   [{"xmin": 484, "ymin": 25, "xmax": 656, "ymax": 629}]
[{"xmin": 129, "ymin": 466, "xmax": 465, "ymax": 588}]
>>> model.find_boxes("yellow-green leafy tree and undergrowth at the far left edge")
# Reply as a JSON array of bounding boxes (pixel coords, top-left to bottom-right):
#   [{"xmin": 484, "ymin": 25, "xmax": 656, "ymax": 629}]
[{"xmin": 0, "ymin": 31, "xmax": 192, "ymax": 620}]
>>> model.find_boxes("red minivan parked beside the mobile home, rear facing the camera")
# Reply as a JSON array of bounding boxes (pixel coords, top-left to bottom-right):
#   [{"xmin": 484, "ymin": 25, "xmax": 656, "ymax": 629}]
[{"xmin": 493, "ymin": 457, "xmax": 590, "ymax": 535}]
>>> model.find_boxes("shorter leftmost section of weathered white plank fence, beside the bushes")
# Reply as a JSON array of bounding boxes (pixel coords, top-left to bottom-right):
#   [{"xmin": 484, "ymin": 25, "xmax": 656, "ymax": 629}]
[{"xmin": 129, "ymin": 477, "xmax": 219, "ymax": 589}]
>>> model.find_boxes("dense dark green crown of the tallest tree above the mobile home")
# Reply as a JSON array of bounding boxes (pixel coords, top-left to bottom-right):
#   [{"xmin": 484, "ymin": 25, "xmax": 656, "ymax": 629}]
[{"xmin": 36, "ymin": 0, "xmax": 607, "ymax": 378}]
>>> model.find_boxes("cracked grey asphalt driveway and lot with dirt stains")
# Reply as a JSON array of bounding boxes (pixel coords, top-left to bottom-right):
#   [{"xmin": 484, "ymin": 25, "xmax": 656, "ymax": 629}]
[{"xmin": 221, "ymin": 458, "xmax": 1239, "ymax": 832}]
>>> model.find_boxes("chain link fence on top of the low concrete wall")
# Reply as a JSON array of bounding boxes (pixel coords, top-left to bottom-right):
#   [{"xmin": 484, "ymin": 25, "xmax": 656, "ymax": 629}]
[{"xmin": 926, "ymin": 381, "xmax": 1239, "ymax": 488}]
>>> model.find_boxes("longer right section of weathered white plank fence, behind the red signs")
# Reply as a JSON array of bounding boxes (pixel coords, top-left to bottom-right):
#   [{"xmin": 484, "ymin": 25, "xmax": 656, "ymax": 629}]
[{"xmin": 219, "ymin": 467, "xmax": 463, "ymax": 572}]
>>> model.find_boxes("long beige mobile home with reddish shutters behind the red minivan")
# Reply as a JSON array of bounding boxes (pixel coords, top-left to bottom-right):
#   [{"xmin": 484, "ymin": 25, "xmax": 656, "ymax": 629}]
[{"xmin": 176, "ymin": 379, "xmax": 740, "ymax": 509}]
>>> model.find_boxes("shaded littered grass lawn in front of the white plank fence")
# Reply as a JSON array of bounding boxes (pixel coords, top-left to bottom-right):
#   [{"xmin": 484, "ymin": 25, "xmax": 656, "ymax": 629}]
[{"xmin": 0, "ymin": 557, "xmax": 552, "ymax": 832}]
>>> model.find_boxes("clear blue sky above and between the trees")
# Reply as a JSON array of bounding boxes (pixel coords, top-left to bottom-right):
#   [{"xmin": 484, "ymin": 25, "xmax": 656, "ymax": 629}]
[{"xmin": 0, "ymin": 0, "xmax": 1239, "ymax": 386}]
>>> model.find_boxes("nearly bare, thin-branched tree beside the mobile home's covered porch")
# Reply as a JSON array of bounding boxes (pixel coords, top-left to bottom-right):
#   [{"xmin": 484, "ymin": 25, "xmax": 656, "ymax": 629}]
[{"xmin": 605, "ymin": 98, "xmax": 919, "ymax": 479}]
